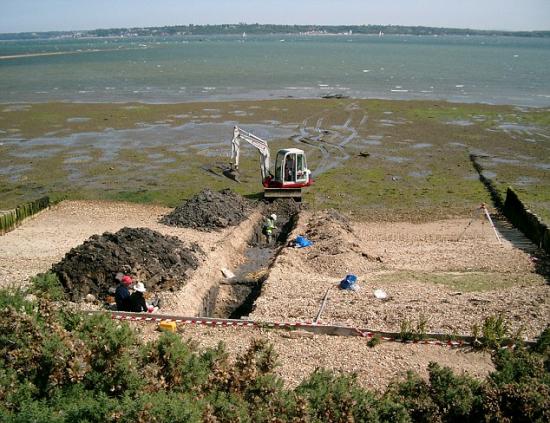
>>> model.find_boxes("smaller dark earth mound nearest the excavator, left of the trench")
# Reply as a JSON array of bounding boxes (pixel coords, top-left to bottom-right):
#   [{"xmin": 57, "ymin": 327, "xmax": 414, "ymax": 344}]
[{"xmin": 161, "ymin": 189, "xmax": 251, "ymax": 231}]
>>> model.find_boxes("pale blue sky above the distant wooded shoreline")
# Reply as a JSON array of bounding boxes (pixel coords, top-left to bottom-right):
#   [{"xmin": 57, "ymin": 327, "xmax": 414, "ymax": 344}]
[{"xmin": 0, "ymin": 0, "xmax": 550, "ymax": 33}]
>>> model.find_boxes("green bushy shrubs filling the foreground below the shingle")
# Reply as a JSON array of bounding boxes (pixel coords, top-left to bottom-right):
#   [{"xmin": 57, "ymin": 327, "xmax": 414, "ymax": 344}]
[{"xmin": 0, "ymin": 279, "xmax": 550, "ymax": 422}]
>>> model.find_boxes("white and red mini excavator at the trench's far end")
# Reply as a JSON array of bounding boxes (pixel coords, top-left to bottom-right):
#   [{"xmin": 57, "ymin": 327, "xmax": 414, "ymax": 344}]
[{"xmin": 227, "ymin": 126, "xmax": 313, "ymax": 201}]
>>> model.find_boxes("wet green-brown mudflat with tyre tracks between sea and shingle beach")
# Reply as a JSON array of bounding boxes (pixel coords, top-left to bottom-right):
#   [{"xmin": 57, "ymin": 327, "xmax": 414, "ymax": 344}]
[{"xmin": 0, "ymin": 99, "xmax": 550, "ymax": 220}]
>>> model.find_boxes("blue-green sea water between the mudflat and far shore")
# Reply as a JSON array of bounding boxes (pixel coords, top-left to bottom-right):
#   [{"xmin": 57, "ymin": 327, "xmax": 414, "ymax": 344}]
[{"xmin": 0, "ymin": 35, "xmax": 550, "ymax": 106}]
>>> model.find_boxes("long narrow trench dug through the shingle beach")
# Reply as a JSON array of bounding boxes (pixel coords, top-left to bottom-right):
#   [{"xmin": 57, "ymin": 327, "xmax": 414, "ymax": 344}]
[{"xmin": 201, "ymin": 207, "xmax": 299, "ymax": 319}]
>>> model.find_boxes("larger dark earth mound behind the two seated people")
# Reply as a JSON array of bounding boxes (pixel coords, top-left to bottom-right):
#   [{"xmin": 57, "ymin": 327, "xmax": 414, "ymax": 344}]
[{"xmin": 52, "ymin": 228, "xmax": 203, "ymax": 301}]
